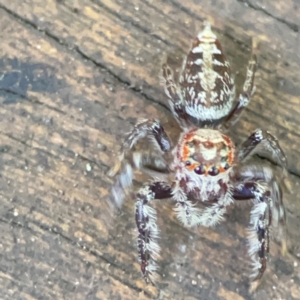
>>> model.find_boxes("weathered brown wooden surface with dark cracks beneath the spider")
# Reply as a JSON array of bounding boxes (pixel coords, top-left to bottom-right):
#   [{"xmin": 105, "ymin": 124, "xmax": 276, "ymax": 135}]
[{"xmin": 0, "ymin": 0, "xmax": 300, "ymax": 300}]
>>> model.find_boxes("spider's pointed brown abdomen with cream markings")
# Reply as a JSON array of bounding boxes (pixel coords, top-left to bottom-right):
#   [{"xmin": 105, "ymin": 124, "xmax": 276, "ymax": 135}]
[{"xmin": 179, "ymin": 25, "xmax": 235, "ymax": 126}]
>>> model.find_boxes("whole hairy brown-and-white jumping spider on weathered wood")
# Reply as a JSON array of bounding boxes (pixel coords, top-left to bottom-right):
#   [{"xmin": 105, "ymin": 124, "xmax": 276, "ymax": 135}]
[{"xmin": 111, "ymin": 23, "xmax": 287, "ymax": 283}]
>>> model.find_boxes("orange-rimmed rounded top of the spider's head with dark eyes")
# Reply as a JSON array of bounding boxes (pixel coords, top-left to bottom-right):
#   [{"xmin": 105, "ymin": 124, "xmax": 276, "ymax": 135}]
[{"xmin": 180, "ymin": 129, "xmax": 234, "ymax": 176}]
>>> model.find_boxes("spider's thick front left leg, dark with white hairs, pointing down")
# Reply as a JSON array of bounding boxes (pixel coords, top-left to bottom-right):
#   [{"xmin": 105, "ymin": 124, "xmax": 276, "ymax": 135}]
[{"xmin": 135, "ymin": 182, "xmax": 172, "ymax": 283}]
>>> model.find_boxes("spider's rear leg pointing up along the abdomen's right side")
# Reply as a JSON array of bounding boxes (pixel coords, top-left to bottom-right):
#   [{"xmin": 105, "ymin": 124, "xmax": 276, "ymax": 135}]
[{"xmin": 223, "ymin": 54, "xmax": 257, "ymax": 128}]
